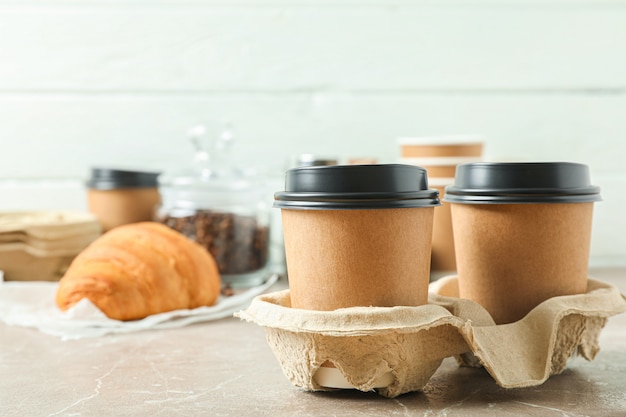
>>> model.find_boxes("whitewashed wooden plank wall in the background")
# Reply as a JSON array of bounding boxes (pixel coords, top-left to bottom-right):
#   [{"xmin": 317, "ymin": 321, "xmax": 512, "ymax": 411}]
[{"xmin": 0, "ymin": 0, "xmax": 626, "ymax": 265}]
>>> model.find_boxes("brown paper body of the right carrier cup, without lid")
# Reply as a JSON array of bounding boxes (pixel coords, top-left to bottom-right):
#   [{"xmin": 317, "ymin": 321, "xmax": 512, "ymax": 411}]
[{"xmin": 451, "ymin": 203, "xmax": 593, "ymax": 324}]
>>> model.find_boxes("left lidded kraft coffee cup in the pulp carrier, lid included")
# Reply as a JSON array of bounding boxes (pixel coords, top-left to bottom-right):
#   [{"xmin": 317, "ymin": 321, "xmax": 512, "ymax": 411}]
[{"xmin": 274, "ymin": 164, "xmax": 440, "ymax": 310}]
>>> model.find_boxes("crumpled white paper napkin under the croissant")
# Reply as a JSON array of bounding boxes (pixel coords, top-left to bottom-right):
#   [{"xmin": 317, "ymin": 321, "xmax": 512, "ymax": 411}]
[{"xmin": 0, "ymin": 275, "xmax": 278, "ymax": 340}]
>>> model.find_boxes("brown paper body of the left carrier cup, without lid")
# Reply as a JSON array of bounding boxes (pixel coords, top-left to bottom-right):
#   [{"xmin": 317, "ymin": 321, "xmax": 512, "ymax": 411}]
[{"xmin": 282, "ymin": 207, "xmax": 433, "ymax": 310}]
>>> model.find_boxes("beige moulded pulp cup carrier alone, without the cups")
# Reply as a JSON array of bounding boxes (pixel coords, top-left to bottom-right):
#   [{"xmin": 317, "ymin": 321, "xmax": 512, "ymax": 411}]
[{"xmin": 235, "ymin": 277, "xmax": 626, "ymax": 398}]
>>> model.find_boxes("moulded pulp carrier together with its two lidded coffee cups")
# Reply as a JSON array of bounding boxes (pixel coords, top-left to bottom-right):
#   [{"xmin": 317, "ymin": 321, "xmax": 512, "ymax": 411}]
[{"xmin": 235, "ymin": 164, "xmax": 626, "ymax": 398}]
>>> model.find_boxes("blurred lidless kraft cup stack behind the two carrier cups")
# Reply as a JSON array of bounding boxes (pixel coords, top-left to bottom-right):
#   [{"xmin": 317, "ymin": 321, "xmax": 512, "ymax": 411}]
[{"xmin": 398, "ymin": 135, "xmax": 484, "ymax": 273}]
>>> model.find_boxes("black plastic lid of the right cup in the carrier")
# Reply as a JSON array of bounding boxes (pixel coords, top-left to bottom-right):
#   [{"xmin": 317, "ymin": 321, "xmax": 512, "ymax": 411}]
[{"xmin": 443, "ymin": 162, "xmax": 601, "ymax": 204}]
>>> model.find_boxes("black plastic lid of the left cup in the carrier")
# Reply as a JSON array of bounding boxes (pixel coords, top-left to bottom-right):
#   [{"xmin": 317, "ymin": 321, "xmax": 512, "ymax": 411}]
[{"xmin": 274, "ymin": 164, "xmax": 441, "ymax": 210}]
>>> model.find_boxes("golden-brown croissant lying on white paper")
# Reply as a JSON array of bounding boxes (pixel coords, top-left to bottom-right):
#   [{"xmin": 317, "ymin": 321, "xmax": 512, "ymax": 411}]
[{"xmin": 56, "ymin": 222, "xmax": 221, "ymax": 320}]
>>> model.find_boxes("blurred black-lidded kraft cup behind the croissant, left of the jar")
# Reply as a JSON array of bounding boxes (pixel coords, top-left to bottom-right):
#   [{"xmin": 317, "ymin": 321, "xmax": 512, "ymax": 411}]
[{"xmin": 87, "ymin": 168, "xmax": 161, "ymax": 232}]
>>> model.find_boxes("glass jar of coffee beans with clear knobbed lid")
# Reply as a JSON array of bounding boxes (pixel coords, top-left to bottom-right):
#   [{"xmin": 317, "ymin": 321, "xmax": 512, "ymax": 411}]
[{"xmin": 157, "ymin": 125, "xmax": 270, "ymax": 287}]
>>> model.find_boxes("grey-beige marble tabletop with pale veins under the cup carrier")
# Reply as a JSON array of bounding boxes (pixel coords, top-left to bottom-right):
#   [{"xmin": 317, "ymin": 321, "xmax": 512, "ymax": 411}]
[{"xmin": 0, "ymin": 268, "xmax": 626, "ymax": 417}]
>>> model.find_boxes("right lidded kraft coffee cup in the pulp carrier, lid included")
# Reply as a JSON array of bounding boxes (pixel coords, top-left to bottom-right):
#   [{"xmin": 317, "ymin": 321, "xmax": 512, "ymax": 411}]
[{"xmin": 444, "ymin": 162, "xmax": 601, "ymax": 324}]
